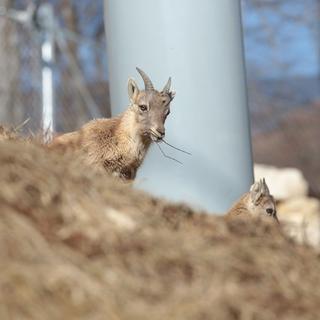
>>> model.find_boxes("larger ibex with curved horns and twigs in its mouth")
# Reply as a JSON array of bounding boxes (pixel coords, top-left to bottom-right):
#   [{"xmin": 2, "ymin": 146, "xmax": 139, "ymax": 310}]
[{"xmin": 49, "ymin": 68, "xmax": 175, "ymax": 180}]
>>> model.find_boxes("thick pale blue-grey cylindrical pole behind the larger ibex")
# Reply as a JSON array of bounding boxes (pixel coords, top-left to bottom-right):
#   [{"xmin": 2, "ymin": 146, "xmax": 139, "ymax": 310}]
[{"xmin": 105, "ymin": 0, "xmax": 253, "ymax": 212}]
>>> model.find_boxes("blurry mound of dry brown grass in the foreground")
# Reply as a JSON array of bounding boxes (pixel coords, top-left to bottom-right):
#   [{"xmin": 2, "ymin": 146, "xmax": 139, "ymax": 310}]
[{"xmin": 0, "ymin": 141, "xmax": 320, "ymax": 320}]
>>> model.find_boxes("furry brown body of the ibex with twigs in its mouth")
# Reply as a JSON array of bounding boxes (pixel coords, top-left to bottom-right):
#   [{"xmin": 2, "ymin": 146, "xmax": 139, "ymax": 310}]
[{"xmin": 50, "ymin": 110, "xmax": 151, "ymax": 179}]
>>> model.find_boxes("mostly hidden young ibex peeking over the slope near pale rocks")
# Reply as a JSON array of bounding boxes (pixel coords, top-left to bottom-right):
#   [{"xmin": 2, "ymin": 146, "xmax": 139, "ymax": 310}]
[{"xmin": 226, "ymin": 179, "xmax": 278, "ymax": 222}]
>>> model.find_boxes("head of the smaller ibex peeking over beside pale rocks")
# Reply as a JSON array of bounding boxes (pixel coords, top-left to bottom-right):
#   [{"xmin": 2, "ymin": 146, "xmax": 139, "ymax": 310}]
[{"xmin": 250, "ymin": 179, "xmax": 278, "ymax": 220}]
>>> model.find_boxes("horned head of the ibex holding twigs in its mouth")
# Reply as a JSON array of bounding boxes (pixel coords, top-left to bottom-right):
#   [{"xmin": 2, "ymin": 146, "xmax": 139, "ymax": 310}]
[{"xmin": 128, "ymin": 68, "xmax": 175, "ymax": 141}]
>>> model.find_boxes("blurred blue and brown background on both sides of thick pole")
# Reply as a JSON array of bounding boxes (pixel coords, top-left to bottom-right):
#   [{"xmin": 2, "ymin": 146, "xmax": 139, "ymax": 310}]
[{"xmin": 0, "ymin": 0, "xmax": 320, "ymax": 197}]
